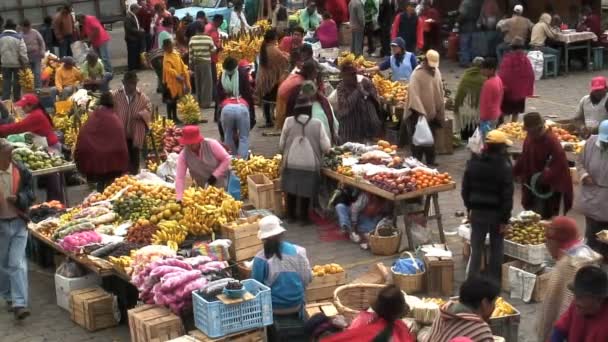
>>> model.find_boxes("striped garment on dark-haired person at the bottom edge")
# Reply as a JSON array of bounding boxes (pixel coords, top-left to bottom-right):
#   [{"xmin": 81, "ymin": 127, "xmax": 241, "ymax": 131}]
[{"xmin": 428, "ymin": 302, "xmax": 494, "ymax": 342}]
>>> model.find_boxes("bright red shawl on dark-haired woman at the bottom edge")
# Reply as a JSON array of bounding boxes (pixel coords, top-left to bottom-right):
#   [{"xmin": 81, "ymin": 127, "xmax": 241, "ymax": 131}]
[{"xmin": 321, "ymin": 312, "xmax": 416, "ymax": 342}]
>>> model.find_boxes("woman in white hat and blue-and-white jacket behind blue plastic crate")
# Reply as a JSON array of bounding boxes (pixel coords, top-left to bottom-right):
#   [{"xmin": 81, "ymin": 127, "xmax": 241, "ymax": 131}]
[{"xmin": 251, "ymin": 215, "xmax": 312, "ymax": 315}]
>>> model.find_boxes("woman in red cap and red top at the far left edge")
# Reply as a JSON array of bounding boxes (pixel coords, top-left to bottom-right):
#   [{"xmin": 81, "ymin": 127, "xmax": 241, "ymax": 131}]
[{"xmin": 0, "ymin": 94, "xmax": 64, "ymax": 201}]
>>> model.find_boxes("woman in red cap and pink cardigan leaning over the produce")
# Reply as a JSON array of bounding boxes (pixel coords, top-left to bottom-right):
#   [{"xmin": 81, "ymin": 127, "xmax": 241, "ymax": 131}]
[{"xmin": 175, "ymin": 126, "xmax": 230, "ymax": 201}]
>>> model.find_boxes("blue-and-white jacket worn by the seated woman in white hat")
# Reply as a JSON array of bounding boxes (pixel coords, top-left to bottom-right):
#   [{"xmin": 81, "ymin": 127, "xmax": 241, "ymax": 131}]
[{"xmin": 251, "ymin": 241, "xmax": 312, "ymax": 309}]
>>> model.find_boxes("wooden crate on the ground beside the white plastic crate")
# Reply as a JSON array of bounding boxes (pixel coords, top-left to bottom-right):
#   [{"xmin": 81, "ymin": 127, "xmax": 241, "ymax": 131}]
[{"xmin": 70, "ymin": 287, "xmax": 118, "ymax": 331}]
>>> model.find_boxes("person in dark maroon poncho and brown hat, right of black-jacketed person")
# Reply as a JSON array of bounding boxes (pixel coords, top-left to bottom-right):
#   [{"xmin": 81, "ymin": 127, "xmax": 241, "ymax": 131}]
[{"xmin": 513, "ymin": 112, "xmax": 574, "ymax": 220}]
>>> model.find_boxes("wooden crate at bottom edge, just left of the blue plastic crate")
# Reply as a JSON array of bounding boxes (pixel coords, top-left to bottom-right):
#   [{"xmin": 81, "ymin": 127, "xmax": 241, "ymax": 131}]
[{"xmin": 128, "ymin": 305, "xmax": 184, "ymax": 342}]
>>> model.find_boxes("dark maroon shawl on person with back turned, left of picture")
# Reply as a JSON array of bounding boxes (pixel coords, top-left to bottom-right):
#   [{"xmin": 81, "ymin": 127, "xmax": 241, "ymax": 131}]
[{"xmin": 74, "ymin": 107, "xmax": 129, "ymax": 176}]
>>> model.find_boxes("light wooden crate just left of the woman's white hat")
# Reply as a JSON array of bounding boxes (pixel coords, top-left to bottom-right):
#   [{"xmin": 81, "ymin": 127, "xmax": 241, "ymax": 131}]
[{"xmin": 221, "ymin": 216, "xmax": 263, "ymax": 262}]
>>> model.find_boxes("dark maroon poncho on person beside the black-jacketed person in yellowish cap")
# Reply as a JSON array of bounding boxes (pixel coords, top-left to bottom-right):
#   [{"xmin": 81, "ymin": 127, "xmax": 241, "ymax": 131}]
[{"xmin": 513, "ymin": 131, "xmax": 574, "ymax": 214}]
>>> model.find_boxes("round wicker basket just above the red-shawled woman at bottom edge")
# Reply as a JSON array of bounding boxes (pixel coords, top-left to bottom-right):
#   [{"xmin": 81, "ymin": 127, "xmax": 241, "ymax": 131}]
[{"xmin": 334, "ymin": 284, "xmax": 386, "ymax": 321}]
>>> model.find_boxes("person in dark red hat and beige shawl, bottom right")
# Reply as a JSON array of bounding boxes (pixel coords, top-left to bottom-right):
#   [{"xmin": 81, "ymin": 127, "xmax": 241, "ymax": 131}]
[{"xmin": 537, "ymin": 216, "xmax": 602, "ymax": 341}]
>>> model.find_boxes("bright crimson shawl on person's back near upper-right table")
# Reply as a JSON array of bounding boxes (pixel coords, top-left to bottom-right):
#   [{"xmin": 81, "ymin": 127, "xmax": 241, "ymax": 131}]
[{"xmin": 498, "ymin": 51, "xmax": 534, "ymax": 101}]
